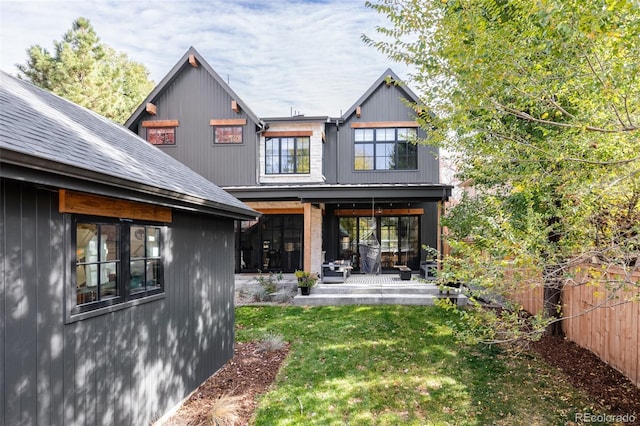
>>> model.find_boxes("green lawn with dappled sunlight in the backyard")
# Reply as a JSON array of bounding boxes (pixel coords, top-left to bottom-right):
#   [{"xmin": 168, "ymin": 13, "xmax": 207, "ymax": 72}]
[{"xmin": 236, "ymin": 306, "xmax": 601, "ymax": 425}]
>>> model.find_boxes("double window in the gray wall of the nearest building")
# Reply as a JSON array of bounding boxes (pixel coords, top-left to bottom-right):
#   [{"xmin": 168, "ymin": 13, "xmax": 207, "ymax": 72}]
[{"xmin": 72, "ymin": 217, "xmax": 164, "ymax": 313}]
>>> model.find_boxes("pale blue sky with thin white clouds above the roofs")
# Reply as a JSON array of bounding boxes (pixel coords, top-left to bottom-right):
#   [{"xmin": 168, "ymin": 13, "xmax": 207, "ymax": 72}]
[{"xmin": 0, "ymin": 0, "xmax": 409, "ymax": 117}]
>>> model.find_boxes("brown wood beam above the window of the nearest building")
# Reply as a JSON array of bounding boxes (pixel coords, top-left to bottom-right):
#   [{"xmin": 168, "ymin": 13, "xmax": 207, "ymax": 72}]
[{"xmin": 58, "ymin": 189, "xmax": 172, "ymax": 223}]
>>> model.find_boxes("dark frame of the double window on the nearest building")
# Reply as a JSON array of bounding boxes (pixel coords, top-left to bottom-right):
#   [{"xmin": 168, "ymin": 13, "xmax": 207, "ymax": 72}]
[{"xmin": 65, "ymin": 214, "xmax": 168, "ymax": 323}]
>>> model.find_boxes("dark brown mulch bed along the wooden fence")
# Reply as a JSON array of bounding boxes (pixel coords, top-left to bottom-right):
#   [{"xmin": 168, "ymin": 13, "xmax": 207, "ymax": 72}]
[{"xmin": 532, "ymin": 337, "xmax": 640, "ymax": 421}]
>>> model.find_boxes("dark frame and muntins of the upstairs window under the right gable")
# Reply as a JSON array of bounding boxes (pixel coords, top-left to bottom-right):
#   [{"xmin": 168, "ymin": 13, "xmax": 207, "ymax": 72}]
[{"xmin": 353, "ymin": 127, "xmax": 419, "ymax": 172}]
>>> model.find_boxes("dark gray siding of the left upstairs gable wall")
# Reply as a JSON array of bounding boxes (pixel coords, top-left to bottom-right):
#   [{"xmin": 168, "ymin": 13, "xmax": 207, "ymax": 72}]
[{"xmin": 134, "ymin": 64, "xmax": 257, "ymax": 186}]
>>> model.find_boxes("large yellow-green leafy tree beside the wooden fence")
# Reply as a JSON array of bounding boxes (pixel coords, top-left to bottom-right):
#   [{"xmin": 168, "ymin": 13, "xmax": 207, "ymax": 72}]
[{"xmin": 363, "ymin": 0, "xmax": 640, "ymax": 340}]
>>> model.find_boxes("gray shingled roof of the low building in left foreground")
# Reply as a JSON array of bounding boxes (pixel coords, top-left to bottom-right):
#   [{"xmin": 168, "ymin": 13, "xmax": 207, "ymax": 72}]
[{"xmin": 0, "ymin": 71, "xmax": 259, "ymax": 219}]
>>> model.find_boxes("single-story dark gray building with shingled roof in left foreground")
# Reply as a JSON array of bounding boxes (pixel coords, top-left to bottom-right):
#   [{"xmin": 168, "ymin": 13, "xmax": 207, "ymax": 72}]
[{"xmin": 0, "ymin": 73, "xmax": 258, "ymax": 425}]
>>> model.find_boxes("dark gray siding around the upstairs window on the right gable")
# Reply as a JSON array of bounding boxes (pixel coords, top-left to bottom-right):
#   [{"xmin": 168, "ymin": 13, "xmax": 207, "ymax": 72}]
[{"xmin": 325, "ymin": 84, "xmax": 439, "ymax": 184}]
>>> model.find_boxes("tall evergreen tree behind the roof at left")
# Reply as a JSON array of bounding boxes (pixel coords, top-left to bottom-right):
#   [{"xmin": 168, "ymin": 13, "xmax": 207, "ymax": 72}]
[{"xmin": 17, "ymin": 18, "xmax": 154, "ymax": 123}]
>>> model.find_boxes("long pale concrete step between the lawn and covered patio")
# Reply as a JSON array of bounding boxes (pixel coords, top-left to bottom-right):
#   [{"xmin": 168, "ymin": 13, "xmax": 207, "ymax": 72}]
[{"xmin": 293, "ymin": 284, "xmax": 468, "ymax": 306}]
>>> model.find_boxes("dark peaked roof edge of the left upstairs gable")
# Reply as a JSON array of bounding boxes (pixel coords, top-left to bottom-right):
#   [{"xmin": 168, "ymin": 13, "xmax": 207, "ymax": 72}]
[{"xmin": 124, "ymin": 46, "xmax": 262, "ymax": 128}]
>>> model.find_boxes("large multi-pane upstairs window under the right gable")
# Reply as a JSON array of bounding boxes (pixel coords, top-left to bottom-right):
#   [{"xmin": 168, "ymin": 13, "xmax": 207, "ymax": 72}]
[{"xmin": 354, "ymin": 127, "xmax": 418, "ymax": 170}]
